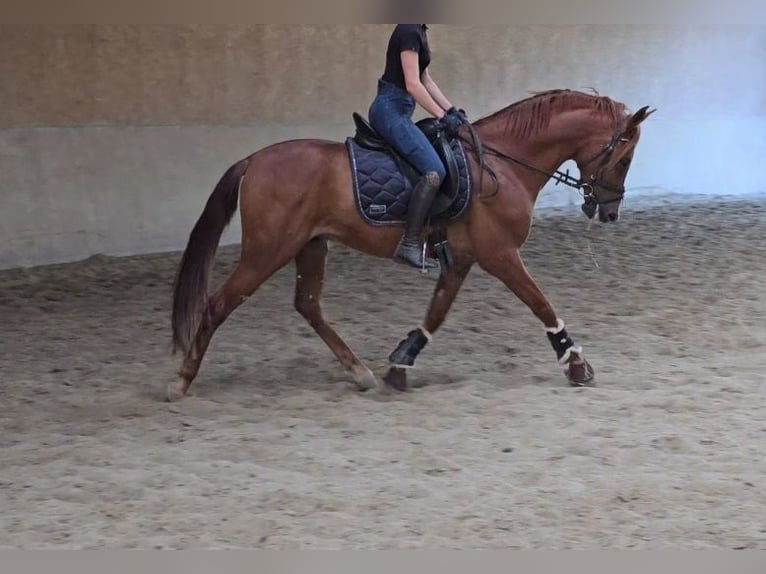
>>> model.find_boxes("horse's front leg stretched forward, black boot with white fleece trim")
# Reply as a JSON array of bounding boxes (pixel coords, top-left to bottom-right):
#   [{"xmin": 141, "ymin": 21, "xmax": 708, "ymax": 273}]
[{"xmin": 479, "ymin": 249, "xmax": 594, "ymax": 387}]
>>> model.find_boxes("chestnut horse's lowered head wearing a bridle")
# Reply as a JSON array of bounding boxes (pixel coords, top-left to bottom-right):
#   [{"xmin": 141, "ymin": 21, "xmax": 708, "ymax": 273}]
[{"xmin": 574, "ymin": 106, "xmax": 654, "ymax": 223}]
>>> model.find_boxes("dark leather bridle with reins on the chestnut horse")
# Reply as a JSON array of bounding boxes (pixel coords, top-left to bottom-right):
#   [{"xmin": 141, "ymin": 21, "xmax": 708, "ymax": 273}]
[{"xmin": 460, "ymin": 124, "xmax": 630, "ymax": 219}]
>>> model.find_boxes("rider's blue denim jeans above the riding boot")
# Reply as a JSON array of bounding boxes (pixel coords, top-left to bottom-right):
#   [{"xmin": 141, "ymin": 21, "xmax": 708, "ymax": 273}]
[{"xmin": 369, "ymin": 80, "xmax": 447, "ymax": 181}]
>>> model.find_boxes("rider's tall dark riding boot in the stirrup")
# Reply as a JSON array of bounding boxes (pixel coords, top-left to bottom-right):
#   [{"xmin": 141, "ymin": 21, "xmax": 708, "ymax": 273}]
[{"xmin": 394, "ymin": 171, "xmax": 441, "ymax": 269}]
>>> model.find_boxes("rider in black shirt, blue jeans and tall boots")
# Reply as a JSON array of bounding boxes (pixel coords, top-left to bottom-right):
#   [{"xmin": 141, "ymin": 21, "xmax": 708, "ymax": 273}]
[{"xmin": 369, "ymin": 24, "xmax": 467, "ymax": 269}]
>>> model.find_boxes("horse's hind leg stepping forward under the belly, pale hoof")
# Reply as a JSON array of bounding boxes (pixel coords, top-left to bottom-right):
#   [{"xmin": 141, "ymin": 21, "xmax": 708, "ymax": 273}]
[{"xmin": 295, "ymin": 238, "xmax": 377, "ymax": 391}]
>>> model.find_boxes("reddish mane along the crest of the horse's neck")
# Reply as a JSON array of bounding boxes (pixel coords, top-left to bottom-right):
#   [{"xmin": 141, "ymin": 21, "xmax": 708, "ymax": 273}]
[{"xmin": 476, "ymin": 89, "xmax": 626, "ymax": 138}]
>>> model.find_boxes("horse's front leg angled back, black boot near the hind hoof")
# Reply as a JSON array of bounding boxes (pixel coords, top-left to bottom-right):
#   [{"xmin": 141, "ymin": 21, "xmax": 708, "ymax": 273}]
[{"xmin": 383, "ymin": 264, "xmax": 473, "ymax": 391}]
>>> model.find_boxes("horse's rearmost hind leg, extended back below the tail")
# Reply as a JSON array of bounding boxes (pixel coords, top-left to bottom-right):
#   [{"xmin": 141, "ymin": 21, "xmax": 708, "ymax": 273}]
[{"xmin": 167, "ymin": 257, "xmax": 284, "ymax": 401}]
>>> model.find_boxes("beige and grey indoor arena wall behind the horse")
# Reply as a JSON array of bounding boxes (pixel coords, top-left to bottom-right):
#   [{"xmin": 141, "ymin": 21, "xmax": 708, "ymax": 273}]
[{"xmin": 0, "ymin": 24, "xmax": 766, "ymax": 267}]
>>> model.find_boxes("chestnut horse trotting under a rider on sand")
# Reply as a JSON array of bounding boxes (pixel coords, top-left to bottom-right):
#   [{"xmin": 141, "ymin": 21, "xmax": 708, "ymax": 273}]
[{"xmin": 168, "ymin": 90, "xmax": 652, "ymax": 400}]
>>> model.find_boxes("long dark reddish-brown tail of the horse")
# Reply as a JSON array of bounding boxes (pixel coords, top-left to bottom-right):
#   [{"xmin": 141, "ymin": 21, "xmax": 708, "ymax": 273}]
[{"xmin": 172, "ymin": 159, "xmax": 248, "ymax": 353}]
